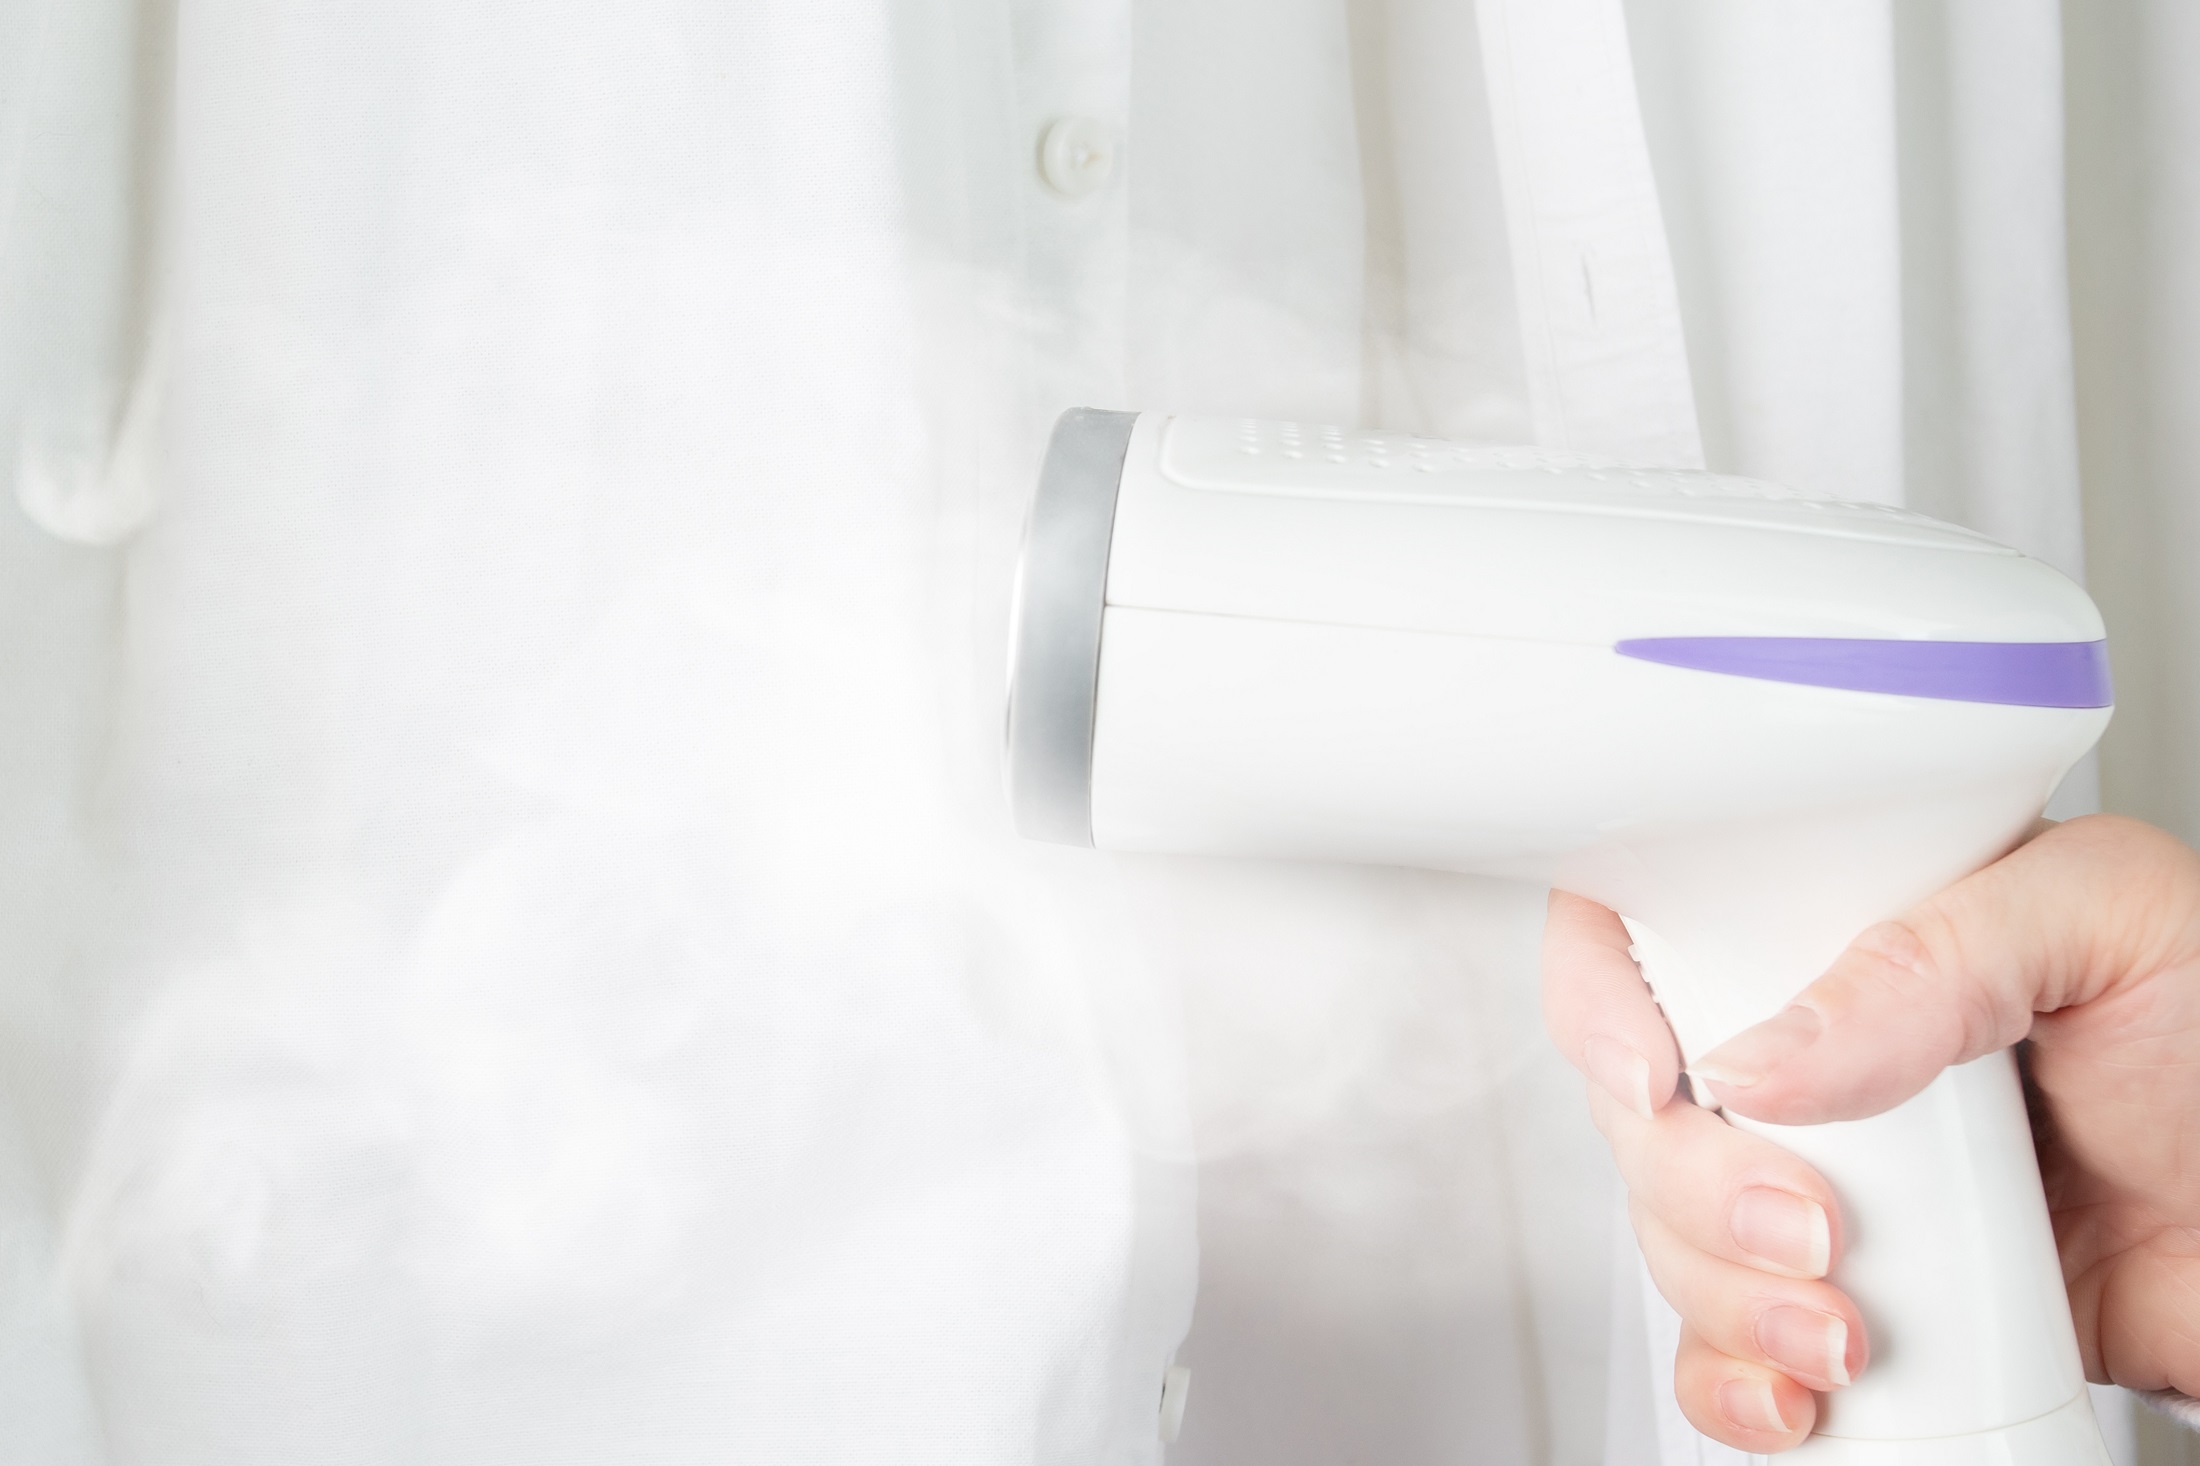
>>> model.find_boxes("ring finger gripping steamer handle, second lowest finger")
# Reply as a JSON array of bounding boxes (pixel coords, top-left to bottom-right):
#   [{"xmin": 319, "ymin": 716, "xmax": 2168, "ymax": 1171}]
[{"xmin": 1628, "ymin": 1204, "xmax": 1866, "ymax": 1391}]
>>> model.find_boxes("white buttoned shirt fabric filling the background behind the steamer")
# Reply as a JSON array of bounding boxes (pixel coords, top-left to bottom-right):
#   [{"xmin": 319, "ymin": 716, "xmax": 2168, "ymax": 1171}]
[{"xmin": 0, "ymin": 0, "xmax": 2200, "ymax": 1466}]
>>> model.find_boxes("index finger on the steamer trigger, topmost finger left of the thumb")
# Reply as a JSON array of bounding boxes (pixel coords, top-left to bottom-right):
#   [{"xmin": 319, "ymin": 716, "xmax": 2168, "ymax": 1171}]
[{"xmin": 1542, "ymin": 891, "xmax": 1681, "ymax": 1116}]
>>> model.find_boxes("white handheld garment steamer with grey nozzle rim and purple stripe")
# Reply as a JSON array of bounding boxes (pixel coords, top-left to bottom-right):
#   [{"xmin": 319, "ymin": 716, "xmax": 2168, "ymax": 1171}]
[{"xmin": 1008, "ymin": 409, "xmax": 2110, "ymax": 1466}]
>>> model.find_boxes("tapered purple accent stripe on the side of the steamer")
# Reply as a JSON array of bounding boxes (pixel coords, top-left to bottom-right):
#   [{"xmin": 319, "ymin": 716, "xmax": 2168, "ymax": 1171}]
[{"xmin": 1613, "ymin": 636, "xmax": 2114, "ymax": 707}]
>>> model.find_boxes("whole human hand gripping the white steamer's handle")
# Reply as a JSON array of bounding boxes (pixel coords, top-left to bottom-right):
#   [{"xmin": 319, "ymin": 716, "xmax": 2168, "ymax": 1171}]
[{"xmin": 1542, "ymin": 814, "xmax": 2200, "ymax": 1451}]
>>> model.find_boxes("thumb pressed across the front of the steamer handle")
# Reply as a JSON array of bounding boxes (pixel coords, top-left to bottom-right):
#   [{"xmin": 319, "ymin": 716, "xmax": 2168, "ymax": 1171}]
[{"xmin": 1692, "ymin": 814, "xmax": 2200, "ymax": 1125}]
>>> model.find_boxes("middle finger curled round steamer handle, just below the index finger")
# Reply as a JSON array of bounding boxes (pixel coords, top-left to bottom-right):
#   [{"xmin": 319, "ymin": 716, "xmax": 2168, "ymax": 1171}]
[{"xmin": 1588, "ymin": 1092, "xmax": 1841, "ymax": 1277}]
